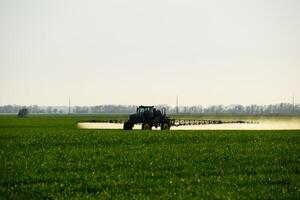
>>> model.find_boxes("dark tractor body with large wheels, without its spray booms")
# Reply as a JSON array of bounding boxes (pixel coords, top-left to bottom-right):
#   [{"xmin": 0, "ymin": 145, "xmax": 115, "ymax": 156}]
[{"xmin": 123, "ymin": 106, "xmax": 172, "ymax": 130}]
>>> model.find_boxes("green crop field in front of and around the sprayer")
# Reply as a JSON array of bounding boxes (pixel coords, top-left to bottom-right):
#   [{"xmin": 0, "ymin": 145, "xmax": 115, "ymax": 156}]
[{"xmin": 0, "ymin": 115, "xmax": 300, "ymax": 199}]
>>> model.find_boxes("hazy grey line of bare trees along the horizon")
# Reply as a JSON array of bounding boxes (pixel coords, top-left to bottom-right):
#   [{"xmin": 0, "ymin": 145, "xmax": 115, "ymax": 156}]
[{"xmin": 0, "ymin": 103, "xmax": 300, "ymax": 114}]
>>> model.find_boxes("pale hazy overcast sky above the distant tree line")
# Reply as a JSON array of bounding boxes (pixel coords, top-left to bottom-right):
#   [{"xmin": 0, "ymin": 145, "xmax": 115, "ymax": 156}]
[{"xmin": 0, "ymin": 0, "xmax": 300, "ymax": 105}]
